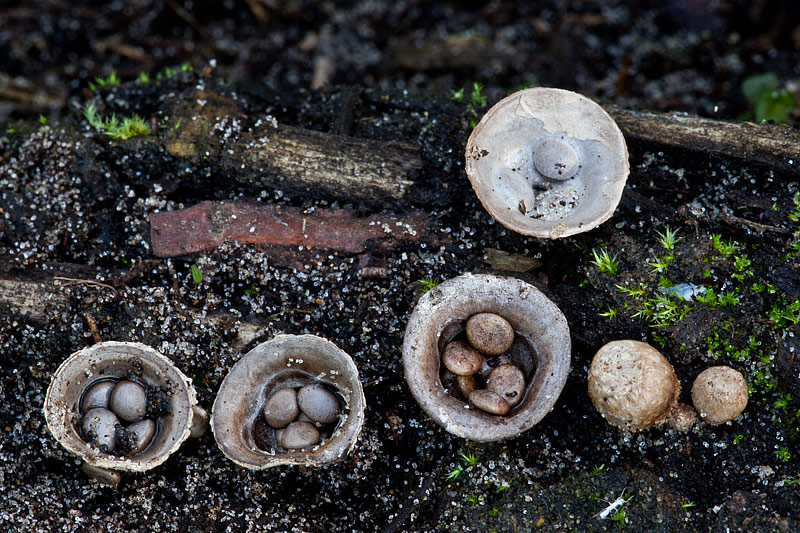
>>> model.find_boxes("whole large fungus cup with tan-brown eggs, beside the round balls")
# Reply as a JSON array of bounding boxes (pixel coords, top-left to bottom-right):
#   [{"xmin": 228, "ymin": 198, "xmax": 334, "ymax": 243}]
[{"xmin": 403, "ymin": 274, "xmax": 570, "ymax": 442}]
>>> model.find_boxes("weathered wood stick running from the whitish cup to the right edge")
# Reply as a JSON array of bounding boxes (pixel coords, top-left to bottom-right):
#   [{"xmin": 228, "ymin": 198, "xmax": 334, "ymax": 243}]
[{"xmin": 606, "ymin": 106, "xmax": 800, "ymax": 176}]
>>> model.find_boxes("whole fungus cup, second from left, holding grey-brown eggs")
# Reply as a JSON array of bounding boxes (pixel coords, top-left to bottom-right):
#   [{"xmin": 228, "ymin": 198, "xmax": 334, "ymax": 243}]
[{"xmin": 211, "ymin": 335, "xmax": 364, "ymax": 470}]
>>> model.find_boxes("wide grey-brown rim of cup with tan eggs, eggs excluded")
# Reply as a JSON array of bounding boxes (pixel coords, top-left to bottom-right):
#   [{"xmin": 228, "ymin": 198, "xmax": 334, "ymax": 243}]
[{"xmin": 403, "ymin": 274, "xmax": 570, "ymax": 442}]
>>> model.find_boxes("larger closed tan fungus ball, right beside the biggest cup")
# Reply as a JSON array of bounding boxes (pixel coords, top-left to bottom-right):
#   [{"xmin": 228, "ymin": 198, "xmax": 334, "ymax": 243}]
[{"xmin": 589, "ymin": 340, "xmax": 680, "ymax": 431}]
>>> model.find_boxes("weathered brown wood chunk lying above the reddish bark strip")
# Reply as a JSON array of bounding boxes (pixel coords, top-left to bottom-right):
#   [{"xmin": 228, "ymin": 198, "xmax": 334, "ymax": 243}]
[{"xmin": 165, "ymin": 91, "xmax": 422, "ymax": 208}]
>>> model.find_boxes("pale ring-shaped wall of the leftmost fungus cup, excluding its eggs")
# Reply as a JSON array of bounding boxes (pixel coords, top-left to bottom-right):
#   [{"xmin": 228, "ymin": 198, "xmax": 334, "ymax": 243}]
[{"xmin": 44, "ymin": 341, "xmax": 205, "ymax": 472}]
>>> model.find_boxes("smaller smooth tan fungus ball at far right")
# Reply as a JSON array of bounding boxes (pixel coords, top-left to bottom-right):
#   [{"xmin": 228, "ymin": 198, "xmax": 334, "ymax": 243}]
[{"xmin": 692, "ymin": 366, "xmax": 747, "ymax": 425}]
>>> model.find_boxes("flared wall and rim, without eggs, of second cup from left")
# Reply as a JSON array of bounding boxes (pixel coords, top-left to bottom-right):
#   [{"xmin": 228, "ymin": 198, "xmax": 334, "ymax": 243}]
[{"xmin": 211, "ymin": 335, "xmax": 365, "ymax": 470}]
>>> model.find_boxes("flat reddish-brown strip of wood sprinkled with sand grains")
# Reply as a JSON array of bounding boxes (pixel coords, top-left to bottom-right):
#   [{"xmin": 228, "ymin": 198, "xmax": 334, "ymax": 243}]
[{"xmin": 150, "ymin": 202, "xmax": 432, "ymax": 257}]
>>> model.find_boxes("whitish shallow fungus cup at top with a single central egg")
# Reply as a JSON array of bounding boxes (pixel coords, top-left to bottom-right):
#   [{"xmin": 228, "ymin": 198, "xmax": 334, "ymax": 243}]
[{"xmin": 465, "ymin": 88, "xmax": 630, "ymax": 239}]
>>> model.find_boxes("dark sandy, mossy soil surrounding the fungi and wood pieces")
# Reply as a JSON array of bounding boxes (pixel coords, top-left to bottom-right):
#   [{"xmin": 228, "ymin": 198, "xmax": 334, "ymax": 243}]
[{"xmin": 0, "ymin": 0, "xmax": 800, "ymax": 531}]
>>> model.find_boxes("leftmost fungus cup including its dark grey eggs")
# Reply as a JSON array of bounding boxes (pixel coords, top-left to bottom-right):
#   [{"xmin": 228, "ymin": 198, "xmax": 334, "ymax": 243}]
[{"xmin": 44, "ymin": 342, "xmax": 208, "ymax": 484}]
